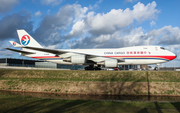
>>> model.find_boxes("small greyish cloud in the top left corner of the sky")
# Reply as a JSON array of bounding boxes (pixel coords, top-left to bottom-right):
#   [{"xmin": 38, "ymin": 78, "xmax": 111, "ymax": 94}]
[{"xmin": 0, "ymin": 0, "xmax": 19, "ymax": 13}]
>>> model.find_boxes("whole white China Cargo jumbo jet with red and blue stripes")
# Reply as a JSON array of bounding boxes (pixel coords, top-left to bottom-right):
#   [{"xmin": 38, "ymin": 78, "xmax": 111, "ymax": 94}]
[{"xmin": 6, "ymin": 30, "xmax": 176, "ymax": 70}]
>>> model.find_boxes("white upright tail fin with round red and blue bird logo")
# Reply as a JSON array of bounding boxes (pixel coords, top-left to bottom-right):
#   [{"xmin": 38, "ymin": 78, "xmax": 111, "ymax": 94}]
[{"xmin": 17, "ymin": 30, "xmax": 43, "ymax": 48}]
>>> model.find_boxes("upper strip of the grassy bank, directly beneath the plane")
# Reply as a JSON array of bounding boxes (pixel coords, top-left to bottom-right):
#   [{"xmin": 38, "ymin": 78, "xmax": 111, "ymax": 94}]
[{"xmin": 0, "ymin": 69, "xmax": 180, "ymax": 82}]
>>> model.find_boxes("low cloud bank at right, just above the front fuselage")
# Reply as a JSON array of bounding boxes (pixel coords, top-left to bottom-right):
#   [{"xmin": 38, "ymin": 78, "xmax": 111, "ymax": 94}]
[{"xmin": 69, "ymin": 23, "xmax": 180, "ymax": 50}]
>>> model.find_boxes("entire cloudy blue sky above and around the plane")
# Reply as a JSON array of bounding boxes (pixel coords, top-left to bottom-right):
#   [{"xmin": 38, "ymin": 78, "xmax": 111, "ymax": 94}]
[{"xmin": 0, "ymin": 0, "xmax": 180, "ymax": 66}]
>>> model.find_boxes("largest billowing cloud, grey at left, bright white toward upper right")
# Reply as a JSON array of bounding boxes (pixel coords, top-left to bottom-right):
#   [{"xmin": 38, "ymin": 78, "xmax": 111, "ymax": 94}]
[{"xmin": 36, "ymin": 1, "xmax": 160, "ymax": 47}]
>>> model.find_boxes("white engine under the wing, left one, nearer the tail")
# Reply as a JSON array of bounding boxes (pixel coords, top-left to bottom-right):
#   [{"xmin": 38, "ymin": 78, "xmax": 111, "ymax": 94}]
[{"xmin": 63, "ymin": 55, "xmax": 87, "ymax": 64}]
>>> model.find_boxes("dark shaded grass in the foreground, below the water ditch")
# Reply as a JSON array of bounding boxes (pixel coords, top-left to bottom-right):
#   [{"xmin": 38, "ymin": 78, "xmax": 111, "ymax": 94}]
[{"xmin": 0, "ymin": 94, "xmax": 180, "ymax": 113}]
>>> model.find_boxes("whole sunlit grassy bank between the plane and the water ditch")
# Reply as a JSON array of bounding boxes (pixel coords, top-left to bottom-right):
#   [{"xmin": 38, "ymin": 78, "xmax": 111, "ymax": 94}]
[{"xmin": 0, "ymin": 69, "xmax": 180, "ymax": 96}]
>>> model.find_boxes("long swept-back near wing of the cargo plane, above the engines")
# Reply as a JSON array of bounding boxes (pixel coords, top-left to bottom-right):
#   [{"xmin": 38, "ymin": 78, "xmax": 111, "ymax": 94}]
[{"xmin": 23, "ymin": 46, "xmax": 125, "ymax": 62}]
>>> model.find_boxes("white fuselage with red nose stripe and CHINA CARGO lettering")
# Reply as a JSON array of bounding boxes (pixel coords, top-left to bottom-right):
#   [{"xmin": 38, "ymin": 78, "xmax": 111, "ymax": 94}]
[{"xmin": 25, "ymin": 46, "xmax": 176, "ymax": 65}]
